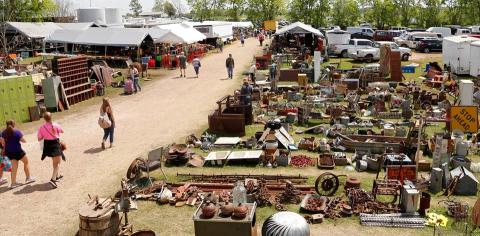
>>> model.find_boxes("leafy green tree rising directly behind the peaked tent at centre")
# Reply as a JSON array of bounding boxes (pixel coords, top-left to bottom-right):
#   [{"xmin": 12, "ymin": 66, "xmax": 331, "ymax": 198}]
[{"xmin": 288, "ymin": 0, "xmax": 330, "ymax": 27}]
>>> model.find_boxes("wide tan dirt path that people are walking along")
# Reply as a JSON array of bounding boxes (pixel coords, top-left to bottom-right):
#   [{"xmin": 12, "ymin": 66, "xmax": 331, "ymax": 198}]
[{"xmin": 0, "ymin": 39, "xmax": 260, "ymax": 235}]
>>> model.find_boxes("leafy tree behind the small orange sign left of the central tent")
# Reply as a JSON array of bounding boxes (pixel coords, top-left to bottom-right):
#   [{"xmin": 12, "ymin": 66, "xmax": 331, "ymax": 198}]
[{"xmin": 247, "ymin": 0, "xmax": 286, "ymax": 25}]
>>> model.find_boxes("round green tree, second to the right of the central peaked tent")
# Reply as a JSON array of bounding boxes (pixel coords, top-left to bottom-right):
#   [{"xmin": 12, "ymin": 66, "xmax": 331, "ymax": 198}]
[{"xmin": 365, "ymin": 0, "xmax": 398, "ymax": 29}]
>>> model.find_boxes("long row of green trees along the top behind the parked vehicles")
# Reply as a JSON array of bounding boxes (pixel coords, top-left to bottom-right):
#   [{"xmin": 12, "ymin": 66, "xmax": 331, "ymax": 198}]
[{"xmin": 188, "ymin": 0, "xmax": 480, "ymax": 29}]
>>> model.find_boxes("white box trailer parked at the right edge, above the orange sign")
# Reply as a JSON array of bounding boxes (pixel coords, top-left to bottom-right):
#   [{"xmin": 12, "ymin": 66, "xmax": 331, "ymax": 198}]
[{"xmin": 443, "ymin": 35, "xmax": 480, "ymax": 75}]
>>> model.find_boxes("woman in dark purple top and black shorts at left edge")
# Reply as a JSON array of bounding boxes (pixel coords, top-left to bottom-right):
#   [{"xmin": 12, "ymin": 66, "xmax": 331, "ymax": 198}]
[{"xmin": 0, "ymin": 120, "xmax": 35, "ymax": 189}]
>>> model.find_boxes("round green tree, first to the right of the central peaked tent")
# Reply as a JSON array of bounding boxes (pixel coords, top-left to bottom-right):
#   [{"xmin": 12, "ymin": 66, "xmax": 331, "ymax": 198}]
[{"xmin": 330, "ymin": 0, "xmax": 360, "ymax": 28}]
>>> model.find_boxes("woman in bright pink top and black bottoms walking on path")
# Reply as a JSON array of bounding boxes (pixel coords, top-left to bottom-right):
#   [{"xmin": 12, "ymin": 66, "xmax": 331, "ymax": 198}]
[{"xmin": 38, "ymin": 112, "xmax": 65, "ymax": 188}]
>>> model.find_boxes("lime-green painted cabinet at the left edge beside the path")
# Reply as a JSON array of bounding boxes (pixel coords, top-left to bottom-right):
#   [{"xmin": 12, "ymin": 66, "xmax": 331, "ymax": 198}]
[{"xmin": 0, "ymin": 76, "xmax": 36, "ymax": 124}]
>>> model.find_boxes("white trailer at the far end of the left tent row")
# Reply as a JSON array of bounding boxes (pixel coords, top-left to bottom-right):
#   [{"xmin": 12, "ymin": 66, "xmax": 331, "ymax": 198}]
[{"xmin": 193, "ymin": 22, "xmax": 233, "ymax": 42}]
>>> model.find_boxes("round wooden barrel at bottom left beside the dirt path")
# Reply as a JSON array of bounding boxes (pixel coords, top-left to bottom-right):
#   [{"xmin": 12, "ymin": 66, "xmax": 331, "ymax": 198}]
[{"xmin": 78, "ymin": 199, "xmax": 120, "ymax": 236}]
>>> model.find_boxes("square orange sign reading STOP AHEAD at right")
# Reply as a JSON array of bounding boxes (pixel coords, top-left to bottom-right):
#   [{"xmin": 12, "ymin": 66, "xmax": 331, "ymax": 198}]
[{"xmin": 450, "ymin": 106, "xmax": 478, "ymax": 133}]
